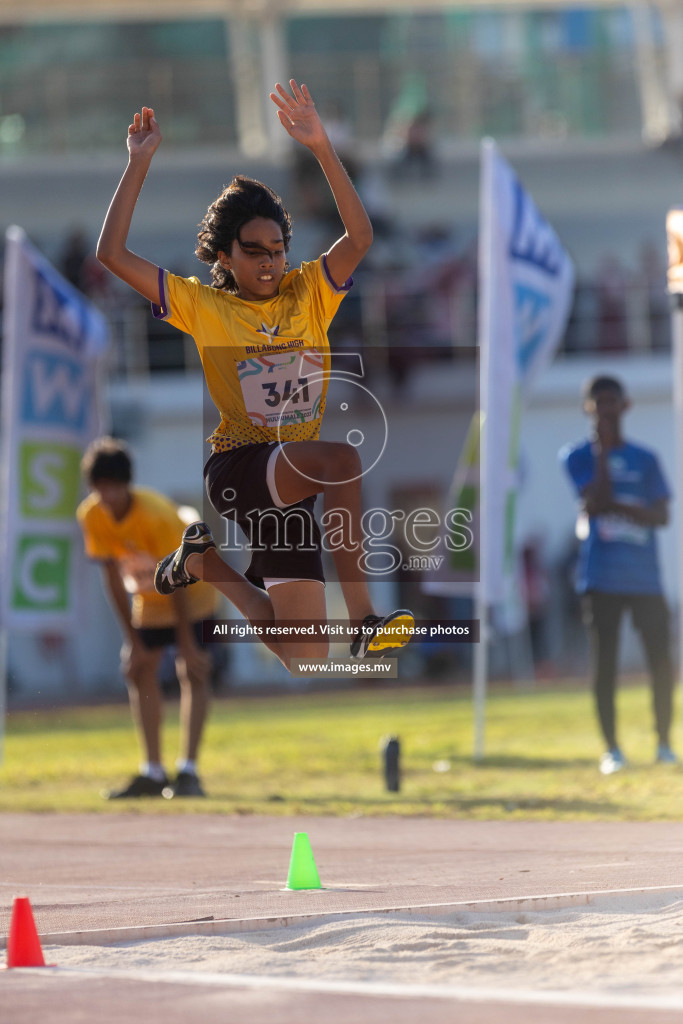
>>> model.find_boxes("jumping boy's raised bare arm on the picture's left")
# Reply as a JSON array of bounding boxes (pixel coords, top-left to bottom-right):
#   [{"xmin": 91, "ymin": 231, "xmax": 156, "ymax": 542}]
[{"xmin": 97, "ymin": 106, "xmax": 161, "ymax": 302}]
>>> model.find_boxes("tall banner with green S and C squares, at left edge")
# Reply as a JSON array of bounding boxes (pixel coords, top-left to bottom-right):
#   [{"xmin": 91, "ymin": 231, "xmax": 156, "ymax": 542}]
[{"xmin": 0, "ymin": 227, "xmax": 108, "ymax": 631}]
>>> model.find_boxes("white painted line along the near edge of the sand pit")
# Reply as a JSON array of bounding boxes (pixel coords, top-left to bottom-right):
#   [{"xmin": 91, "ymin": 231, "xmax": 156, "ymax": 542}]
[{"xmin": 46, "ymin": 968, "xmax": 683, "ymax": 1010}]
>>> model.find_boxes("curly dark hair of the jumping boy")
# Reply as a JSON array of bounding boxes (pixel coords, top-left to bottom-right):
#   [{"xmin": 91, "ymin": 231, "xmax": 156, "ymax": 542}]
[{"xmin": 195, "ymin": 174, "xmax": 292, "ymax": 292}]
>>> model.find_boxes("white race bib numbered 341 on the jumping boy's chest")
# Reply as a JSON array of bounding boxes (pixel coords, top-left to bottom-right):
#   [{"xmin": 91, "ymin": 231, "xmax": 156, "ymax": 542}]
[{"xmin": 238, "ymin": 349, "xmax": 324, "ymax": 430}]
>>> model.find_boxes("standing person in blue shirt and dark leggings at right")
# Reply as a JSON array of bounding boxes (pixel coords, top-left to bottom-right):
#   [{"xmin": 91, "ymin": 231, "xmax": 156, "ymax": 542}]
[{"xmin": 560, "ymin": 377, "xmax": 677, "ymax": 775}]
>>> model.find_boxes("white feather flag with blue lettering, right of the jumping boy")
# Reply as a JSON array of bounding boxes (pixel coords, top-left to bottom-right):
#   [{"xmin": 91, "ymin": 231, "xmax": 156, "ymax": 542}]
[{"xmin": 478, "ymin": 139, "xmax": 574, "ymax": 605}]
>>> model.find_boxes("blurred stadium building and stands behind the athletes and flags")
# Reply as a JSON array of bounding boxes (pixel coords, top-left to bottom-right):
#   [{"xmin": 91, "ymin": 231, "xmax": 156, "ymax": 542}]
[{"xmin": 0, "ymin": 0, "xmax": 683, "ymax": 694}]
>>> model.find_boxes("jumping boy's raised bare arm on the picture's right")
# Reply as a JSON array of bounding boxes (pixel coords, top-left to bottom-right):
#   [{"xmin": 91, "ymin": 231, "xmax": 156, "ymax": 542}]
[{"xmin": 270, "ymin": 79, "xmax": 373, "ymax": 285}]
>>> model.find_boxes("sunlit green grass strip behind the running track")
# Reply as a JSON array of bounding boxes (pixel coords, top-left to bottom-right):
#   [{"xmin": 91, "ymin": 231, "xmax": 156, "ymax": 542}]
[{"xmin": 0, "ymin": 684, "xmax": 683, "ymax": 821}]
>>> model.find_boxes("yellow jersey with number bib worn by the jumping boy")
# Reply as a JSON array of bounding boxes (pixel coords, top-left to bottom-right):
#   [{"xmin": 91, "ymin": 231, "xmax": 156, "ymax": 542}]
[{"xmin": 153, "ymin": 256, "xmax": 351, "ymax": 452}]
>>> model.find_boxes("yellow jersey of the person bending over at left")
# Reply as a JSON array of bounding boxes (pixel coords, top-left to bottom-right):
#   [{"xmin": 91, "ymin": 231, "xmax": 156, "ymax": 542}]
[{"xmin": 76, "ymin": 487, "xmax": 216, "ymax": 629}]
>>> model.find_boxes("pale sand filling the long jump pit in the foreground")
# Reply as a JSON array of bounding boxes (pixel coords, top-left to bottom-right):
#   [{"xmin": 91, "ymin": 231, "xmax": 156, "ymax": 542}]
[{"xmin": 38, "ymin": 889, "xmax": 683, "ymax": 1013}]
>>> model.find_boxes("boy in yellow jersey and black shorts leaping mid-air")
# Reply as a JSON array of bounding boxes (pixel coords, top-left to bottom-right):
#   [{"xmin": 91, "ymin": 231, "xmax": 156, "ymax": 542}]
[{"xmin": 97, "ymin": 80, "xmax": 414, "ymax": 669}]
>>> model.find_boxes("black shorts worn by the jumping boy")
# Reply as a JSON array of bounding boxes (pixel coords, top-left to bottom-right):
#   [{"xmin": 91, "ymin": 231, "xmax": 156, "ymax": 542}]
[{"xmin": 204, "ymin": 441, "xmax": 325, "ymax": 588}]
